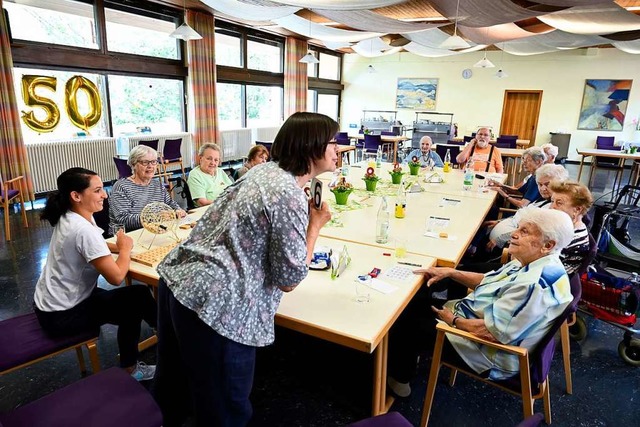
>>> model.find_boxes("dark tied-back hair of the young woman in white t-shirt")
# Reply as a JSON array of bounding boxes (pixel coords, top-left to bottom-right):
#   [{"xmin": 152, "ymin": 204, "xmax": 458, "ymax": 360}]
[{"xmin": 40, "ymin": 168, "xmax": 98, "ymax": 227}]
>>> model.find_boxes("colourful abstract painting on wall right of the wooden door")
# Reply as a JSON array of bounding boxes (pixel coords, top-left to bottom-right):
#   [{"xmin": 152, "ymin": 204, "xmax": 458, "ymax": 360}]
[{"xmin": 578, "ymin": 79, "xmax": 633, "ymax": 131}]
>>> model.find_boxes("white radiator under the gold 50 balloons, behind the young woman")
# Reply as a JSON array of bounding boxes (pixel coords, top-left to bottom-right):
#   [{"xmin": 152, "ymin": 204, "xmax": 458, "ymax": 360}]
[{"xmin": 25, "ymin": 137, "xmax": 117, "ymax": 193}]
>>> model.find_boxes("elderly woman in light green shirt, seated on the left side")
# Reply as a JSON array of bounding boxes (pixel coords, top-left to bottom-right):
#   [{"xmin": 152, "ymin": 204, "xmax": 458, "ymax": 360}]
[{"xmin": 187, "ymin": 142, "xmax": 233, "ymax": 206}]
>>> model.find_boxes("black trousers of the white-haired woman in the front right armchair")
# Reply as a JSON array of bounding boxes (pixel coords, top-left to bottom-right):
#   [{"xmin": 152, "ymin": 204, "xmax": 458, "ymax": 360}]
[{"xmin": 388, "ymin": 279, "xmax": 468, "ymax": 383}]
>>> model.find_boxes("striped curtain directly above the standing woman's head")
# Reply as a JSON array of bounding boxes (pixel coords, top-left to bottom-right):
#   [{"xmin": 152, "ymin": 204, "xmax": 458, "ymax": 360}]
[{"xmin": 284, "ymin": 37, "xmax": 309, "ymax": 120}]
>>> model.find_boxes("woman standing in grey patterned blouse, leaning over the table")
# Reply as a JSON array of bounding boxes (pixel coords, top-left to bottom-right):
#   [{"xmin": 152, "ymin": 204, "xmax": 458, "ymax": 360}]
[{"xmin": 154, "ymin": 113, "xmax": 338, "ymax": 427}]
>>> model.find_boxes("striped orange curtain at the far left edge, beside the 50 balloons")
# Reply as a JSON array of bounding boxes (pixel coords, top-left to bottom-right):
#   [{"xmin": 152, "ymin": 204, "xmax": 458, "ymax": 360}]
[{"xmin": 0, "ymin": 0, "xmax": 35, "ymax": 200}]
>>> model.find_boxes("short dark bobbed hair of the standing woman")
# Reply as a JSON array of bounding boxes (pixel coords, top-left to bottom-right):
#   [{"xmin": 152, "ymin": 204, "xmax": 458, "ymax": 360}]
[{"xmin": 271, "ymin": 112, "xmax": 340, "ymax": 176}]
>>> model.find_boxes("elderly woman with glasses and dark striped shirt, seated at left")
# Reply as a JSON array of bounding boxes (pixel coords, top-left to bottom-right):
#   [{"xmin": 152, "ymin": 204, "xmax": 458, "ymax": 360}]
[{"xmin": 109, "ymin": 145, "xmax": 187, "ymax": 231}]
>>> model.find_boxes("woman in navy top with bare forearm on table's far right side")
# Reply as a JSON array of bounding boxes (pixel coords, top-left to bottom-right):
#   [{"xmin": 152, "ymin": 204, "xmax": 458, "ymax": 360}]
[{"xmin": 489, "ymin": 147, "xmax": 547, "ymax": 208}]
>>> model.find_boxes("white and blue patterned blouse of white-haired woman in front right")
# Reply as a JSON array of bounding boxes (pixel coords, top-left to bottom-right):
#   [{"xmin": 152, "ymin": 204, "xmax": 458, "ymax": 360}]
[{"xmin": 445, "ymin": 254, "xmax": 573, "ymax": 380}]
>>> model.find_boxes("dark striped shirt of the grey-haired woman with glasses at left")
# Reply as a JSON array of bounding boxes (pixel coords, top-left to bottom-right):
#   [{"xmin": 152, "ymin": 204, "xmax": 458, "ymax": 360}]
[{"xmin": 109, "ymin": 178, "xmax": 181, "ymax": 231}]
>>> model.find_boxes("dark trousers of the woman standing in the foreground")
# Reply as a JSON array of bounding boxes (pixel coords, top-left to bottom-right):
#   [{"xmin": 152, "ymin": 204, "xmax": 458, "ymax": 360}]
[{"xmin": 152, "ymin": 279, "xmax": 256, "ymax": 427}]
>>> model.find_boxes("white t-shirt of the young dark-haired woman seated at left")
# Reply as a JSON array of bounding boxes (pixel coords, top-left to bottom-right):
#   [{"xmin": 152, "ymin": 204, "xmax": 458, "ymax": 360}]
[{"xmin": 33, "ymin": 211, "xmax": 111, "ymax": 311}]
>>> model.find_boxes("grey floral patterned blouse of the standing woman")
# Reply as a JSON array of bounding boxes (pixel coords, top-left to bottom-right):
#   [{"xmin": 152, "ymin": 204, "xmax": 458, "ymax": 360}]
[{"xmin": 158, "ymin": 162, "xmax": 309, "ymax": 347}]
